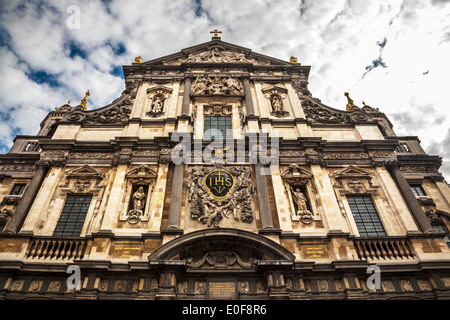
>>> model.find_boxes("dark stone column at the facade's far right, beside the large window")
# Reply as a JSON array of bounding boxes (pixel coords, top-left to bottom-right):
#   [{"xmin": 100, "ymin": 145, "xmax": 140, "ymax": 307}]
[{"xmin": 388, "ymin": 164, "xmax": 433, "ymax": 232}]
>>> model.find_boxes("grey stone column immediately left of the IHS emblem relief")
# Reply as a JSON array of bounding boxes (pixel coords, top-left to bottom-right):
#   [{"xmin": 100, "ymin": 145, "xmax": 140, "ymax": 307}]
[{"xmin": 167, "ymin": 163, "xmax": 184, "ymax": 230}]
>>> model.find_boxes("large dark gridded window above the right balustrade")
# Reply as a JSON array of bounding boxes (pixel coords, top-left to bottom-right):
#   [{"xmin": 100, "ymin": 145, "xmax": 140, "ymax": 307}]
[{"xmin": 347, "ymin": 196, "xmax": 386, "ymax": 237}]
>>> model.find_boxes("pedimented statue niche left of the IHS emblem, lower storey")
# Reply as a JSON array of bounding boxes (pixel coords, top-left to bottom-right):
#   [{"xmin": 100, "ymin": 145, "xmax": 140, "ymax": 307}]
[{"xmin": 119, "ymin": 165, "xmax": 157, "ymax": 224}]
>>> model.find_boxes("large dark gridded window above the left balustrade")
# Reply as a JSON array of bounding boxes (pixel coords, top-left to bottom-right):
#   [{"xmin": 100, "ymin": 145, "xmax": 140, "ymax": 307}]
[{"xmin": 53, "ymin": 195, "xmax": 92, "ymax": 237}]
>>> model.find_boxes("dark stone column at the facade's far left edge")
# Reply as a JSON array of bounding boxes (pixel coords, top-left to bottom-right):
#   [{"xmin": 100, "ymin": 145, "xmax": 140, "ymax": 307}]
[{"xmin": 4, "ymin": 166, "xmax": 48, "ymax": 233}]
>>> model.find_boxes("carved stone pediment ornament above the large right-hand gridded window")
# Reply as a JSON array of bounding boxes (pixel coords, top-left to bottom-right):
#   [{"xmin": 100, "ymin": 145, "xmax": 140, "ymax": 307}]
[{"xmin": 332, "ymin": 165, "xmax": 379, "ymax": 196}]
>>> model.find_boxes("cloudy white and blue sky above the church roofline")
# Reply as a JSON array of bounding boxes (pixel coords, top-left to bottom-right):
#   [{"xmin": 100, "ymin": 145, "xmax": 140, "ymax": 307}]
[{"xmin": 0, "ymin": 0, "xmax": 450, "ymax": 182}]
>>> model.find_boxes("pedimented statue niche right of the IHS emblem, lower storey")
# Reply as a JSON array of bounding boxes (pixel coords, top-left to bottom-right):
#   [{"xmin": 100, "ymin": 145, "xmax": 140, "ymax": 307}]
[{"xmin": 281, "ymin": 164, "xmax": 320, "ymax": 225}]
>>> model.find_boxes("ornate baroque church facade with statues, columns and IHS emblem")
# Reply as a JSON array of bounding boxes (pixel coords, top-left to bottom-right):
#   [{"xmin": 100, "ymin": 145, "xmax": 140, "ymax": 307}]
[{"xmin": 0, "ymin": 30, "xmax": 450, "ymax": 300}]
